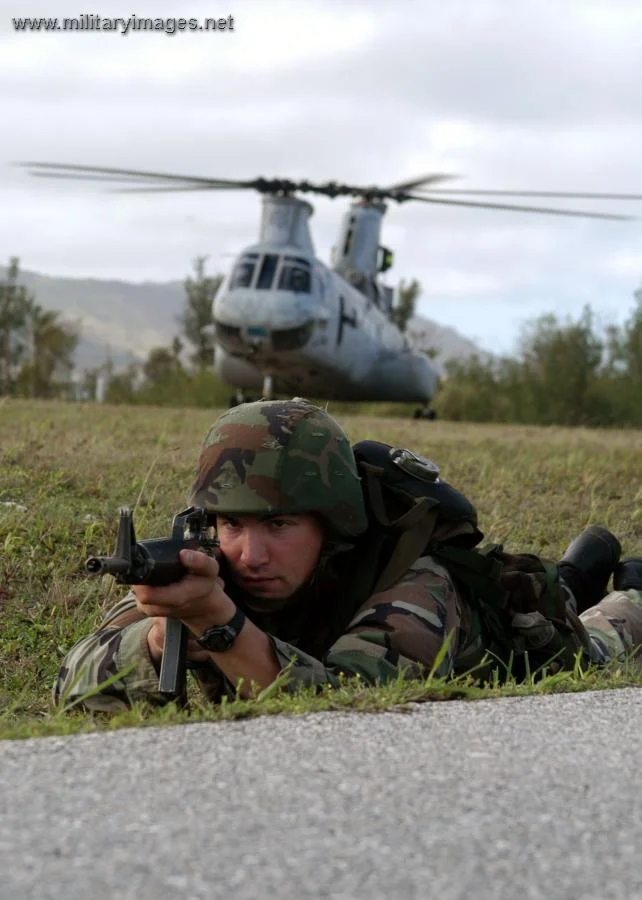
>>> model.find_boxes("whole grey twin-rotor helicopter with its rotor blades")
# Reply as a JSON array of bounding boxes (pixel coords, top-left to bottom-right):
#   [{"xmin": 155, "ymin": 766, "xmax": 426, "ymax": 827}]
[{"xmin": 20, "ymin": 163, "xmax": 642, "ymax": 418}]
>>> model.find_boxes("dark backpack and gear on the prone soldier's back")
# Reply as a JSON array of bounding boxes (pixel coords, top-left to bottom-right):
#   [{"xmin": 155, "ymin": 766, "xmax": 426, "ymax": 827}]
[{"xmin": 352, "ymin": 440, "xmax": 591, "ymax": 679}]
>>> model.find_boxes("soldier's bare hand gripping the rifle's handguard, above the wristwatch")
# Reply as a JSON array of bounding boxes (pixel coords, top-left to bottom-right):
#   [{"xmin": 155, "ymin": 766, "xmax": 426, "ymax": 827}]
[{"xmin": 132, "ymin": 550, "xmax": 236, "ymax": 635}]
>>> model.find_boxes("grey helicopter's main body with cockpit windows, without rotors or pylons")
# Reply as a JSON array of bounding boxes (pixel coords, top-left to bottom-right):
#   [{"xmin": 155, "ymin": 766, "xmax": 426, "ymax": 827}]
[{"xmin": 213, "ymin": 243, "xmax": 438, "ymax": 403}]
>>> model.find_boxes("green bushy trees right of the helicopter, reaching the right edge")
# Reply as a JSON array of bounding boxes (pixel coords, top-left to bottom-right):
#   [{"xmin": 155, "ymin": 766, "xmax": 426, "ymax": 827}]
[{"xmin": 435, "ymin": 302, "xmax": 642, "ymax": 428}]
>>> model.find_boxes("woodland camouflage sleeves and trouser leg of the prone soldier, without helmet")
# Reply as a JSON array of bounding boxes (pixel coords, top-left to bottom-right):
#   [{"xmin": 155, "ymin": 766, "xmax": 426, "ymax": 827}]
[{"xmin": 53, "ymin": 557, "xmax": 642, "ymax": 712}]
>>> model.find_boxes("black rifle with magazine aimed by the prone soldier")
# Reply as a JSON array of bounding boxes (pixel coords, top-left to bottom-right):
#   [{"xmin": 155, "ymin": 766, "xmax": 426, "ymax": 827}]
[{"xmin": 85, "ymin": 506, "xmax": 219, "ymax": 705}]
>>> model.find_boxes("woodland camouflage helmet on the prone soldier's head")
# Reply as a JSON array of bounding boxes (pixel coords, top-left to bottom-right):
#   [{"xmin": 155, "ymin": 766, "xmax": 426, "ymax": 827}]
[{"xmin": 189, "ymin": 397, "xmax": 368, "ymax": 537}]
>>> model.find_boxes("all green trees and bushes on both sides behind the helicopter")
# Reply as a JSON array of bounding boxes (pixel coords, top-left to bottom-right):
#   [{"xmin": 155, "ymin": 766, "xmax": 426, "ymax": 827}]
[{"xmin": 0, "ymin": 257, "xmax": 642, "ymax": 427}]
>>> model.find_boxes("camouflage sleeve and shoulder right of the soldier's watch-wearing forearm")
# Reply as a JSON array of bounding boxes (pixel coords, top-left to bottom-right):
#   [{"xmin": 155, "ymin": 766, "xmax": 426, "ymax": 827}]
[{"xmin": 264, "ymin": 557, "xmax": 462, "ymax": 690}]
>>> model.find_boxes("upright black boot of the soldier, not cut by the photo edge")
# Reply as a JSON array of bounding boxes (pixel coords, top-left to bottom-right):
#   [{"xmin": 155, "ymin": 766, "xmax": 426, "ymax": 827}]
[{"xmin": 559, "ymin": 525, "xmax": 622, "ymax": 615}]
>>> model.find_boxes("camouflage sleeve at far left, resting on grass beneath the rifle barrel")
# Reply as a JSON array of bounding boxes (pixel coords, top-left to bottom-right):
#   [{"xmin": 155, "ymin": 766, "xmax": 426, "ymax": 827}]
[{"xmin": 53, "ymin": 592, "xmax": 167, "ymax": 712}]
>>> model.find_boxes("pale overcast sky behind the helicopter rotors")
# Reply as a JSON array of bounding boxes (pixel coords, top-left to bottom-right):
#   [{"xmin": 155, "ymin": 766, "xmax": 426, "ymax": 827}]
[{"xmin": 0, "ymin": 0, "xmax": 642, "ymax": 352}]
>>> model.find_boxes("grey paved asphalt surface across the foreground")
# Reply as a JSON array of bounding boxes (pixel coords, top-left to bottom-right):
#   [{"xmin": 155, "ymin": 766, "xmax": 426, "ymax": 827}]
[{"xmin": 0, "ymin": 690, "xmax": 642, "ymax": 900}]
